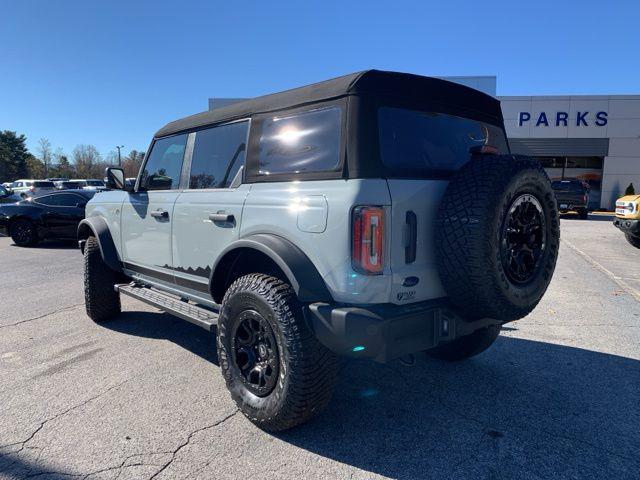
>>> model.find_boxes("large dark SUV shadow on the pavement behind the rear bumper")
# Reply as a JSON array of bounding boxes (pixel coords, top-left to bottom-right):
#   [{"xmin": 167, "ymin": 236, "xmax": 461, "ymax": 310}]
[{"xmin": 276, "ymin": 336, "xmax": 640, "ymax": 479}]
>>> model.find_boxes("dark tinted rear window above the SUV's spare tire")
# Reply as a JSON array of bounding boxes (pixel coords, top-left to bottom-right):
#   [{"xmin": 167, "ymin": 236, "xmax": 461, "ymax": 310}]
[{"xmin": 378, "ymin": 107, "xmax": 509, "ymax": 177}]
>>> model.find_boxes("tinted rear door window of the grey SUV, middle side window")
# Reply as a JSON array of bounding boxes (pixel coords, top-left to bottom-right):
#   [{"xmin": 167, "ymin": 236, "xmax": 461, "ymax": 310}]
[{"xmin": 189, "ymin": 122, "xmax": 249, "ymax": 189}]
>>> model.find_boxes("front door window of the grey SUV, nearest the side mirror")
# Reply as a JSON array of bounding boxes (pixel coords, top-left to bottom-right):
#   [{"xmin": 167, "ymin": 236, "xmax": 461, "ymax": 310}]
[{"xmin": 140, "ymin": 134, "xmax": 187, "ymax": 190}]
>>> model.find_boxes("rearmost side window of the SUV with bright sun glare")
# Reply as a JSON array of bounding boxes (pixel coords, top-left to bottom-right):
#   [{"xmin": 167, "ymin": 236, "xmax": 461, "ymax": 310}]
[{"xmin": 258, "ymin": 107, "xmax": 342, "ymax": 175}]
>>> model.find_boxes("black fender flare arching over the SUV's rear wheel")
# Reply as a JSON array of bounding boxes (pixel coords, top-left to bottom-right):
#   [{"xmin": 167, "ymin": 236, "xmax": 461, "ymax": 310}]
[{"xmin": 209, "ymin": 233, "xmax": 333, "ymax": 303}]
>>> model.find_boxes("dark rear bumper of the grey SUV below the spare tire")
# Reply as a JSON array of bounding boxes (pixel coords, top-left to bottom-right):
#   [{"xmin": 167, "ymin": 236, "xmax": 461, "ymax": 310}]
[{"xmin": 305, "ymin": 300, "xmax": 502, "ymax": 362}]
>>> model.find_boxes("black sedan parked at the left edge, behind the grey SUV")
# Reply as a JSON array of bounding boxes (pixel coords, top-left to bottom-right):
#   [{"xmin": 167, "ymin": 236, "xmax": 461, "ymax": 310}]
[{"xmin": 0, "ymin": 190, "xmax": 96, "ymax": 247}]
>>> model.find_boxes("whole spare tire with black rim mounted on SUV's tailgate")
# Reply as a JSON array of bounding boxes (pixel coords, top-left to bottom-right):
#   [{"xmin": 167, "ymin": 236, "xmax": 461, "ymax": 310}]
[{"xmin": 435, "ymin": 155, "xmax": 560, "ymax": 321}]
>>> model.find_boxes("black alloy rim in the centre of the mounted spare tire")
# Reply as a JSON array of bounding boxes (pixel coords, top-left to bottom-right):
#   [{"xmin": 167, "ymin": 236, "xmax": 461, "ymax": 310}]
[{"xmin": 500, "ymin": 194, "xmax": 546, "ymax": 285}]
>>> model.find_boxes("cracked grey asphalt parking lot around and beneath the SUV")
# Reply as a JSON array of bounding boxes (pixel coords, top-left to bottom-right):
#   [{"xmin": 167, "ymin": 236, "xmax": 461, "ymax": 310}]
[{"xmin": 0, "ymin": 216, "xmax": 640, "ymax": 479}]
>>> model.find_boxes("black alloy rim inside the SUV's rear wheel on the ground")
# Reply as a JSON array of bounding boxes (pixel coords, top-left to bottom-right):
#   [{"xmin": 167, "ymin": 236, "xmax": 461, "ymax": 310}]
[{"xmin": 232, "ymin": 310, "xmax": 280, "ymax": 397}]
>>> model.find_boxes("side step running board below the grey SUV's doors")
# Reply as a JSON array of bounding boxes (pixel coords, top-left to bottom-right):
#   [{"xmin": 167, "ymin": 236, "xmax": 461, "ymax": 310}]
[{"xmin": 114, "ymin": 283, "xmax": 218, "ymax": 331}]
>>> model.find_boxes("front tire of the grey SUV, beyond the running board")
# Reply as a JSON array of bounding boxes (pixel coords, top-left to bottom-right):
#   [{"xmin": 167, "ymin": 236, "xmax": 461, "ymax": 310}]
[{"xmin": 84, "ymin": 237, "xmax": 121, "ymax": 322}]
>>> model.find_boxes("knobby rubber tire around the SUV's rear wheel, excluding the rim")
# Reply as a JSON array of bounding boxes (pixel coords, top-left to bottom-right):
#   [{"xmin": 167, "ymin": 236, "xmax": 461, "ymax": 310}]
[{"xmin": 217, "ymin": 273, "xmax": 336, "ymax": 431}]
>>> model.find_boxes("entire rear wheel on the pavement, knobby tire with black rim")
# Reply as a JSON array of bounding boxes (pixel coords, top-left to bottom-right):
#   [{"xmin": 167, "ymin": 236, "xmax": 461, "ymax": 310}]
[{"xmin": 217, "ymin": 273, "xmax": 336, "ymax": 431}]
